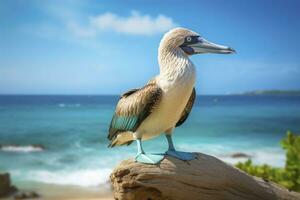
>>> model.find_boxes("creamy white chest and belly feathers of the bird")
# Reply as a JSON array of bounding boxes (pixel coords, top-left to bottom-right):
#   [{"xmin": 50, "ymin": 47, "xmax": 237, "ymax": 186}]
[{"xmin": 138, "ymin": 54, "xmax": 196, "ymax": 139}]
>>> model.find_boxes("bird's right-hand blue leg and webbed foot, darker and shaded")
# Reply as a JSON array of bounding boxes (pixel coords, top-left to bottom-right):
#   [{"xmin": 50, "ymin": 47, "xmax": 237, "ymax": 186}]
[{"xmin": 166, "ymin": 134, "xmax": 196, "ymax": 160}]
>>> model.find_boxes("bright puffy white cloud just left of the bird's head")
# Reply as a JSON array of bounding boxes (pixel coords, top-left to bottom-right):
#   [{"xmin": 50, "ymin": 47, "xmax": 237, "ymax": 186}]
[{"xmin": 90, "ymin": 11, "xmax": 176, "ymax": 35}]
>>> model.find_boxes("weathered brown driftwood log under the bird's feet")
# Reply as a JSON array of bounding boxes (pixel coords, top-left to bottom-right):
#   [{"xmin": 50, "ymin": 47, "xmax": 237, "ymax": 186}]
[{"xmin": 110, "ymin": 153, "xmax": 300, "ymax": 200}]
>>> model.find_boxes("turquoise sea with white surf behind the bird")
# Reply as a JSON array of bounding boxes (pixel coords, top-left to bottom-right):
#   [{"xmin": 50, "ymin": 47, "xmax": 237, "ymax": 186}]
[{"xmin": 0, "ymin": 96, "xmax": 300, "ymax": 186}]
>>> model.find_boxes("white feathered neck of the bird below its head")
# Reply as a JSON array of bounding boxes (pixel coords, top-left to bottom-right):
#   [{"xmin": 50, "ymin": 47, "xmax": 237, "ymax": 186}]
[{"xmin": 158, "ymin": 45, "xmax": 195, "ymax": 84}]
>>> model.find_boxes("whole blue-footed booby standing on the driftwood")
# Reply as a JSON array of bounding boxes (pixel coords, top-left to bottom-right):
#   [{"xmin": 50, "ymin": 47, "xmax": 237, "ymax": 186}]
[{"xmin": 108, "ymin": 28, "xmax": 235, "ymax": 164}]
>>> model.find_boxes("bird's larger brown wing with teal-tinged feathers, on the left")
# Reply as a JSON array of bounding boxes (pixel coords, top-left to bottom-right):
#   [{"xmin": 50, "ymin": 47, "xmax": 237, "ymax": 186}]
[{"xmin": 107, "ymin": 83, "xmax": 162, "ymax": 145}]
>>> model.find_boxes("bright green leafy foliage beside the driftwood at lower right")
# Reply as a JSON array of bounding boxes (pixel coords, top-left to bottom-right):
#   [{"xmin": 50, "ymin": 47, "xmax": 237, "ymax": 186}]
[{"xmin": 236, "ymin": 131, "xmax": 300, "ymax": 192}]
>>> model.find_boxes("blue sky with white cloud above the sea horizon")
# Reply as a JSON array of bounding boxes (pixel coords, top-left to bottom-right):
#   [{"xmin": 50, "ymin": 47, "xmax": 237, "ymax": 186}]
[{"xmin": 0, "ymin": 0, "xmax": 300, "ymax": 94}]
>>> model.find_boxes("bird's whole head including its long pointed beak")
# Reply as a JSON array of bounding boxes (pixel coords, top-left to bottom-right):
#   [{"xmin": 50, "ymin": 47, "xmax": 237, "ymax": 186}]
[{"xmin": 160, "ymin": 28, "xmax": 235, "ymax": 55}]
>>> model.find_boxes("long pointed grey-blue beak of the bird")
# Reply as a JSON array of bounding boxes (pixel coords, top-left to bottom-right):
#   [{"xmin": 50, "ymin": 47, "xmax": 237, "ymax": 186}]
[{"xmin": 189, "ymin": 38, "xmax": 236, "ymax": 54}]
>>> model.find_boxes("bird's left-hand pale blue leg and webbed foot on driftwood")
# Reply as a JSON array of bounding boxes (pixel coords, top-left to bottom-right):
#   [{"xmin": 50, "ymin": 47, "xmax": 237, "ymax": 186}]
[{"xmin": 135, "ymin": 138, "xmax": 164, "ymax": 165}]
